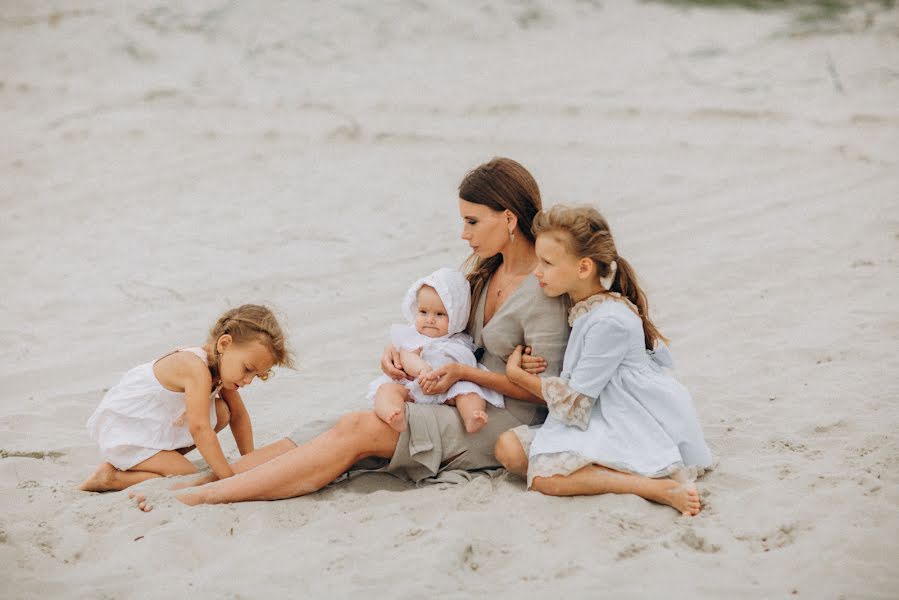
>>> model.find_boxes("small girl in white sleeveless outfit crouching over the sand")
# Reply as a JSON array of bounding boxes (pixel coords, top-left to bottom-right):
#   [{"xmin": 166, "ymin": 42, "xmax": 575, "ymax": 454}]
[{"xmin": 79, "ymin": 304, "xmax": 293, "ymax": 492}]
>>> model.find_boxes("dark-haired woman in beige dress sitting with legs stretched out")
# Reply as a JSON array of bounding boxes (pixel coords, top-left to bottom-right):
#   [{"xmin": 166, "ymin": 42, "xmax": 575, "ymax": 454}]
[{"xmin": 138, "ymin": 158, "xmax": 569, "ymax": 510}]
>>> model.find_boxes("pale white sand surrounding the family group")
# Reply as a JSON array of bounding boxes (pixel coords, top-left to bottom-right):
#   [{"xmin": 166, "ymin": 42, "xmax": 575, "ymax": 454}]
[{"xmin": 0, "ymin": 0, "xmax": 899, "ymax": 599}]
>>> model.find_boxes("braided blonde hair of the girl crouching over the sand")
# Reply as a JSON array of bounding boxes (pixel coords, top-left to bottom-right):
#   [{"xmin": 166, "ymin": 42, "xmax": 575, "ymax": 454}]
[{"xmin": 209, "ymin": 304, "xmax": 294, "ymax": 369}]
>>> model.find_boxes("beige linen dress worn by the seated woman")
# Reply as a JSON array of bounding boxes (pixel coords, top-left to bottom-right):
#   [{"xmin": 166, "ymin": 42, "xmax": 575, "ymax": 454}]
[{"xmin": 289, "ymin": 275, "xmax": 570, "ymax": 482}]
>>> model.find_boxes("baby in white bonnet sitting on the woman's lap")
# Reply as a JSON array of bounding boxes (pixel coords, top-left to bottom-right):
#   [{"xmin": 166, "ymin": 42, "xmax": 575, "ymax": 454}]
[{"xmin": 368, "ymin": 268, "xmax": 505, "ymax": 433}]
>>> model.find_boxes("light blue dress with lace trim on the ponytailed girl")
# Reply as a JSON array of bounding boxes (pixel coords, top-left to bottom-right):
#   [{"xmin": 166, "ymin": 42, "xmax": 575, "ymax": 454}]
[{"xmin": 528, "ymin": 294, "xmax": 712, "ymax": 484}]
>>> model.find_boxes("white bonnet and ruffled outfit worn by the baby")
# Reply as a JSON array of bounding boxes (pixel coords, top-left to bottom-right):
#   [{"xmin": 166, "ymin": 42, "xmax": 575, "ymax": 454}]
[{"xmin": 366, "ymin": 268, "xmax": 505, "ymax": 408}]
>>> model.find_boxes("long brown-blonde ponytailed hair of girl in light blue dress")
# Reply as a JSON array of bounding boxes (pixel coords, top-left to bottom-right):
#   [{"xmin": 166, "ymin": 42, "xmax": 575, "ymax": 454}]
[{"xmin": 533, "ymin": 204, "xmax": 668, "ymax": 350}]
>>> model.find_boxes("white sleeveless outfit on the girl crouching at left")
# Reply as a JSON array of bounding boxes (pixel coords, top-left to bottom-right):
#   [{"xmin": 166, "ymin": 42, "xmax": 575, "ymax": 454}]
[{"xmin": 87, "ymin": 348, "xmax": 219, "ymax": 471}]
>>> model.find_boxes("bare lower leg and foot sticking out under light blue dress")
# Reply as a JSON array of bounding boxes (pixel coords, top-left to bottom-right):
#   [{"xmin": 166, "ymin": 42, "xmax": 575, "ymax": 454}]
[{"xmin": 531, "ymin": 465, "xmax": 701, "ymax": 516}]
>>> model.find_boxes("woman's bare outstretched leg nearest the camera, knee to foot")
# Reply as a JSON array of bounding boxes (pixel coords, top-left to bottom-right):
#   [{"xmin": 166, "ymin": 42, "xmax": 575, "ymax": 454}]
[{"xmin": 178, "ymin": 412, "xmax": 400, "ymax": 506}]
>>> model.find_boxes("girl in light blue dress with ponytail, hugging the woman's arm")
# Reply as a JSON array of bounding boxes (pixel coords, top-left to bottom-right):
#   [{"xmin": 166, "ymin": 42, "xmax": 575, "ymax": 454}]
[{"xmin": 507, "ymin": 206, "xmax": 712, "ymax": 515}]
